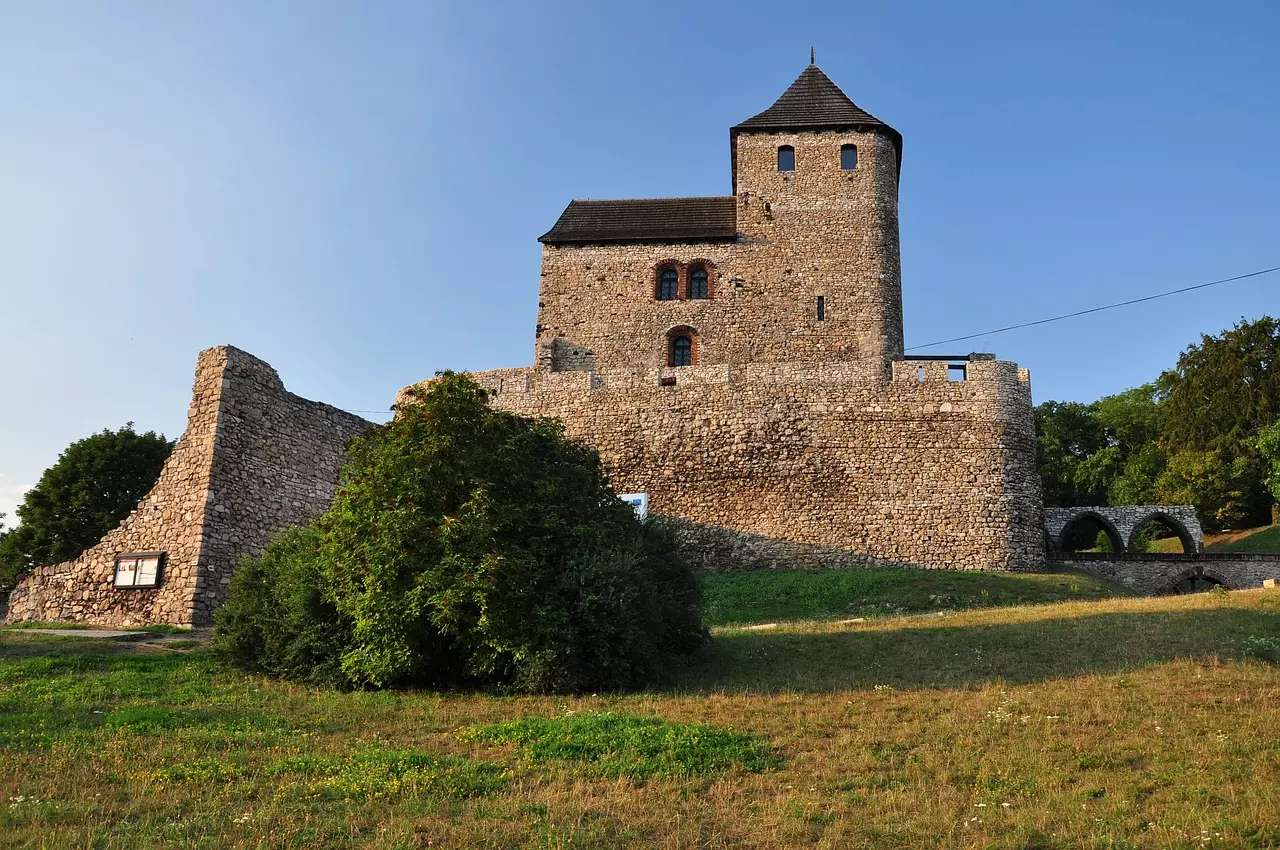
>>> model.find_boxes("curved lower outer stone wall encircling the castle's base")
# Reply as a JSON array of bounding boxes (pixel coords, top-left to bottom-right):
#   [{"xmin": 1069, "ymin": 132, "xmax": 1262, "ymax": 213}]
[{"xmin": 399, "ymin": 361, "xmax": 1044, "ymax": 570}]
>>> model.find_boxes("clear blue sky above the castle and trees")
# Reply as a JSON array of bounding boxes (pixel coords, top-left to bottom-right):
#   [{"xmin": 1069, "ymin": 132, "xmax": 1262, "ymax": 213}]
[{"xmin": 0, "ymin": 0, "xmax": 1280, "ymax": 521}]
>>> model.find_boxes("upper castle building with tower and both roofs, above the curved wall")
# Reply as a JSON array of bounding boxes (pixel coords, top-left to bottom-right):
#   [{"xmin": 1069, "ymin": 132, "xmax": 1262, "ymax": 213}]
[{"xmin": 536, "ymin": 65, "xmax": 902, "ymax": 376}]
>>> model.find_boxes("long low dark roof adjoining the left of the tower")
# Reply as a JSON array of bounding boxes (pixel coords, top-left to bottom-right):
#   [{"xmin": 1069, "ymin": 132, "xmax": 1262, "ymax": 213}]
[{"xmin": 538, "ymin": 197, "xmax": 737, "ymax": 245}]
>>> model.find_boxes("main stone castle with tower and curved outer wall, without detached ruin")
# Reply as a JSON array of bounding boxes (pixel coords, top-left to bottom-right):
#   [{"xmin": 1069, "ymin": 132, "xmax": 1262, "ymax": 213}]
[{"xmin": 398, "ymin": 65, "xmax": 1044, "ymax": 570}]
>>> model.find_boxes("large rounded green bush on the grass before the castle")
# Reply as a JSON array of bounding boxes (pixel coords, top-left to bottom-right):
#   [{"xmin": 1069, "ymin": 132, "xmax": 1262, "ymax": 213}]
[{"xmin": 219, "ymin": 374, "xmax": 705, "ymax": 691}]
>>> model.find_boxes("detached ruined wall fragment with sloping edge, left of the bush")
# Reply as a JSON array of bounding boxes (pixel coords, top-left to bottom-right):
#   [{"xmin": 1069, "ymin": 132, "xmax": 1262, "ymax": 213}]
[{"xmin": 8, "ymin": 346, "xmax": 370, "ymax": 626}]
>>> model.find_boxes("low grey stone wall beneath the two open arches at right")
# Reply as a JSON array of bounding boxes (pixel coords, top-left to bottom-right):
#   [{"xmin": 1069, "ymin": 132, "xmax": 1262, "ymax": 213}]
[{"xmin": 1051, "ymin": 552, "xmax": 1280, "ymax": 597}]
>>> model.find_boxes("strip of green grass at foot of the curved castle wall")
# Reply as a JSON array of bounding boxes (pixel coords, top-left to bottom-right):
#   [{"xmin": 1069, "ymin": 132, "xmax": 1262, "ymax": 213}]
[{"xmin": 701, "ymin": 567, "xmax": 1132, "ymax": 626}]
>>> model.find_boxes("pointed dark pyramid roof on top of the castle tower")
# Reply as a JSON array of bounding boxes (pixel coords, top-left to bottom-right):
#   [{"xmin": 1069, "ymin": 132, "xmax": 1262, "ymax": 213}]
[{"xmin": 728, "ymin": 65, "xmax": 902, "ymax": 183}]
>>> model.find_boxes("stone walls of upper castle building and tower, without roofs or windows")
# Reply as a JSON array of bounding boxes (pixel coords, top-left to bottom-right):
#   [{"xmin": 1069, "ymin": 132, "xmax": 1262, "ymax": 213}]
[{"xmin": 535, "ymin": 132, "xmax": 902, "ymax": 371}]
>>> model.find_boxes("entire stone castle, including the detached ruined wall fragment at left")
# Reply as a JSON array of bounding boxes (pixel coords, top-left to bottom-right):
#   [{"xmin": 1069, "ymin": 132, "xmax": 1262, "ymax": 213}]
[{"xmin": 9, "ymin": 64, "xmax": 1044, "ymax": 625}]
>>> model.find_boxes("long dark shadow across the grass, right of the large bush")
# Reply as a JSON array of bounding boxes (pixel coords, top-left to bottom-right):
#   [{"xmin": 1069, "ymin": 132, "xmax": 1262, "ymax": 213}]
[{"xmin": 675, "ymin": 608, "xmax": 1280, "ymax": 693}]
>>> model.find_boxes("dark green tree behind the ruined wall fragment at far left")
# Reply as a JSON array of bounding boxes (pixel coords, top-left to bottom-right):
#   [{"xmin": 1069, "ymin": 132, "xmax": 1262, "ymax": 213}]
[{"xmin": 0, "ymin": 422, "xmax": 173, "ymax": 588}]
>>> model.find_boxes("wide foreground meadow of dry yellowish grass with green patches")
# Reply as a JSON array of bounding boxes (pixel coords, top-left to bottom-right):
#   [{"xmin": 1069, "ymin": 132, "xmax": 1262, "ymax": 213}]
[{"xmin": 0, "ymin": 573, "xmax": 1280, "ymax": 849}]
